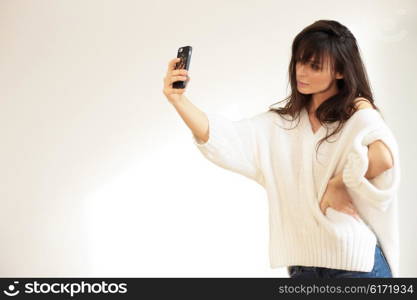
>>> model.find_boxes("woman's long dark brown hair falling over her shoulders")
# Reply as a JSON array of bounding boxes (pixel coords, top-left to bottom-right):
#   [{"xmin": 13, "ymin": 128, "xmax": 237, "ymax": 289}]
[{"xmin": 269, "ymin": 20, "xmax": 382, "ymax": 157}]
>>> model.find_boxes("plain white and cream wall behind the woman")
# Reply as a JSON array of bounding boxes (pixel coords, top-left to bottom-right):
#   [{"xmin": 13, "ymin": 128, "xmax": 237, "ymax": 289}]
[{"xmin": 0, "ymin": 0, "xmax": 417, "ymax": 277}]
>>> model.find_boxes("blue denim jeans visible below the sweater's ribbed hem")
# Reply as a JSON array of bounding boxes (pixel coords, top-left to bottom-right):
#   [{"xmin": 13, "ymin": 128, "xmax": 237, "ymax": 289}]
[{"xmin": 288, "ymin": 245, "xmax": 392, "ymax": 278}]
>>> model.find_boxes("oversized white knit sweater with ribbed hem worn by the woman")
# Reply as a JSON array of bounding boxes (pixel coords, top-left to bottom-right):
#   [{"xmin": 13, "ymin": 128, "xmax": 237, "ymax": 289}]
[{"xmin": 192, "ymin": 108, "xmax": 400, "ymax": 277}]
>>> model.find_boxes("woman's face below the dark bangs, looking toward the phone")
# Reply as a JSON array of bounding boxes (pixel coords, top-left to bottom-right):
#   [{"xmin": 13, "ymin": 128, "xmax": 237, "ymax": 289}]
[{"xmin": 295, "ymin": 57, "xmax": 343, "ymax": 94}]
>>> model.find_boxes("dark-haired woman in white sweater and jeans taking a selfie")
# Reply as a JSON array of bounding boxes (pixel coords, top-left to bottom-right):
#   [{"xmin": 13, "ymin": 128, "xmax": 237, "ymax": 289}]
[{"xmin": 163, "ymin": 20, "xmax": 400, "ymax": 278}]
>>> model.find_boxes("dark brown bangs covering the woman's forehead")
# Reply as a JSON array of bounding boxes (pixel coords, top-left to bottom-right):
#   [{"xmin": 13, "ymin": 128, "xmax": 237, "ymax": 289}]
[{"xmin": 293, "ymin": 34, "xmax": 334, "ymax": 71}]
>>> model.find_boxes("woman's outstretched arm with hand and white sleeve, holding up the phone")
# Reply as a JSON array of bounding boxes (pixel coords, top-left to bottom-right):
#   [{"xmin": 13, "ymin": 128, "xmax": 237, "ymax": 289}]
[{"xmin": 163, "ymin": 59, "xmax": 264, "ymax": 186}]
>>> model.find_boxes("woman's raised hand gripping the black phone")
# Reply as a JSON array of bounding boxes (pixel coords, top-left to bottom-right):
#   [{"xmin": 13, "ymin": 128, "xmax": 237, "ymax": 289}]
[{"xmin": 162, "ymin": 58, "xmax": 190, "ymax": 103}]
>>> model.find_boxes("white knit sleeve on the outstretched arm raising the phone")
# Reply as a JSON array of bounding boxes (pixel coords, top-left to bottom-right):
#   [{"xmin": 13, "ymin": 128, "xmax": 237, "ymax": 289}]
[{"xmin": 192, "ymin": 113, "xmax": 264, "ymax": 186}]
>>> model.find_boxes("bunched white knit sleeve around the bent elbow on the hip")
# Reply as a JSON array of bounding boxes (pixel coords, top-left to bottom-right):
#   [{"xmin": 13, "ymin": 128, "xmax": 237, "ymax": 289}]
[{"xmin": 343, "ymin": 119, "xmax": 400, "ymax": 211}]
